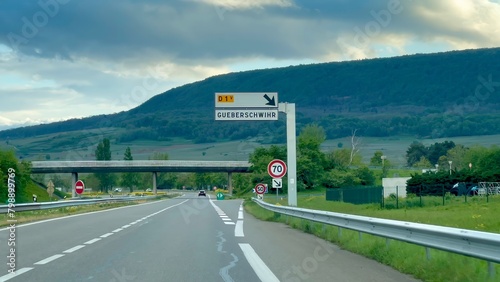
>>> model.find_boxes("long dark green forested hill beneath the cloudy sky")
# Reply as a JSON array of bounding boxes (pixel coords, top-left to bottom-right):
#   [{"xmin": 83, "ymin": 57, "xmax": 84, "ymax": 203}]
[{"xmin": 0, "ymin": 48, "xmax": 500, "ymax": 142}]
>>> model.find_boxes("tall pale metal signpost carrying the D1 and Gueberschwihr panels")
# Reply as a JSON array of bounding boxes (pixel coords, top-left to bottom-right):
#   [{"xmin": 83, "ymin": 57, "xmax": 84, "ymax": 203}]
[{"xmin": 215, "ymin": 92, "xmax": 297, "ymax": 206}]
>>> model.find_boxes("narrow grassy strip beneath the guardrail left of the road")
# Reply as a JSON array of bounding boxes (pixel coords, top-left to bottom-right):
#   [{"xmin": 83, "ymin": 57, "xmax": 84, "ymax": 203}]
[{"xmin": 0, "ymin": 195, "xmax": 178, "ymax": 227}]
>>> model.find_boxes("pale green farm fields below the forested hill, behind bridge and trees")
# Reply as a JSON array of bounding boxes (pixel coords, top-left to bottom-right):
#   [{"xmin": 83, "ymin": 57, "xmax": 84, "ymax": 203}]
[{"xmin": 0, "ymin": 131, "xmax": 500, "ymax": 167}]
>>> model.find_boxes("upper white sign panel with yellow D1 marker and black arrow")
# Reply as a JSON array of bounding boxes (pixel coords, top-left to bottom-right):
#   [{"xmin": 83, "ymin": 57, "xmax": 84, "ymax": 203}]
[{"xmin": 215, "ymin": 92, "xmax": 278, "ymax": 108}]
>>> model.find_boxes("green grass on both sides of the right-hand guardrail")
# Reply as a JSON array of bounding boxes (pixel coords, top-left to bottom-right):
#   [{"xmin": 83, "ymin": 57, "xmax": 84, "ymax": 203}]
[{"xmin": 245, "ymin": 197, "xmax": 500, "ymax": 281}]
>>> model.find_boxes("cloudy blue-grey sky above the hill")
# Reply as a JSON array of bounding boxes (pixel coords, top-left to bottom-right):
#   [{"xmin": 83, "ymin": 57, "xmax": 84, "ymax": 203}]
[{"xmin": 0, "ymin": 0, "xmax": 500, "ymax": 130}]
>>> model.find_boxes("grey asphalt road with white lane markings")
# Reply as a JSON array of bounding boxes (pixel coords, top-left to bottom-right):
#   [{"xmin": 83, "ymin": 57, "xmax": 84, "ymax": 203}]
[{"xmin": 0, "ymin": 193, "xmax": 417, "ymax": 282}]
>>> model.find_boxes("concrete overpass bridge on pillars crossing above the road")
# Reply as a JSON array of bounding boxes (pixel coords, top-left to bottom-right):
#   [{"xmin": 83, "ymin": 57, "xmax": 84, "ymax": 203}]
[{"xmin": 31, "ymin": 160, "xmax": 251, "ymax": 197}]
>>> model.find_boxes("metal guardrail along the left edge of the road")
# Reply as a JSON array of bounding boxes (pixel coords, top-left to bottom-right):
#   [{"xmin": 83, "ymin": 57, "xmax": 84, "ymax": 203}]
[{"xmin": 0, "ymin": 196, "xmax": 156, "ymax": 214}]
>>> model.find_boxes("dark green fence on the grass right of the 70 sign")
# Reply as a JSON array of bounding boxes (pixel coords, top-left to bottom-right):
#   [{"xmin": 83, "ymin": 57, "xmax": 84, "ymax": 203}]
[{"xmin": 326, "ymin": 186, "xmax": 384, "ymax": 204}]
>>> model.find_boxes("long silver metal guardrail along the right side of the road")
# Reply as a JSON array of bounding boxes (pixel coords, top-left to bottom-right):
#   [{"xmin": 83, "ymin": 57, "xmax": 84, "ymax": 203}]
[{"xmin": 252, "ymin": 198, "xmax": 500, "ymax": 263}]
